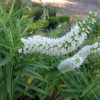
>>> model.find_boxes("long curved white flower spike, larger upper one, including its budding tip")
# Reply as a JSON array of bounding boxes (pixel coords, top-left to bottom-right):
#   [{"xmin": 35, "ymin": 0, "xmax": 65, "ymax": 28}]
[{"xmin": 18, "ymin": 13, "xmax": 94, "ymax": 56}]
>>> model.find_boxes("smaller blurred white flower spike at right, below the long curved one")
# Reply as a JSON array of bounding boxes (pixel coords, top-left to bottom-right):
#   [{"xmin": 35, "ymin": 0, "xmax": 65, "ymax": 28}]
[{"xmin": 58, "ymin": 42, "xmax": 100, "ymax": 73}]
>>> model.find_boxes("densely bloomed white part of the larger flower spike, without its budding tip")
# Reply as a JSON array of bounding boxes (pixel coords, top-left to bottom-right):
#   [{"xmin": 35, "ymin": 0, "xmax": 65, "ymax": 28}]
[{"xmin": 18, "ymin": 24, "xmax": 86, "ymax": 55}]
